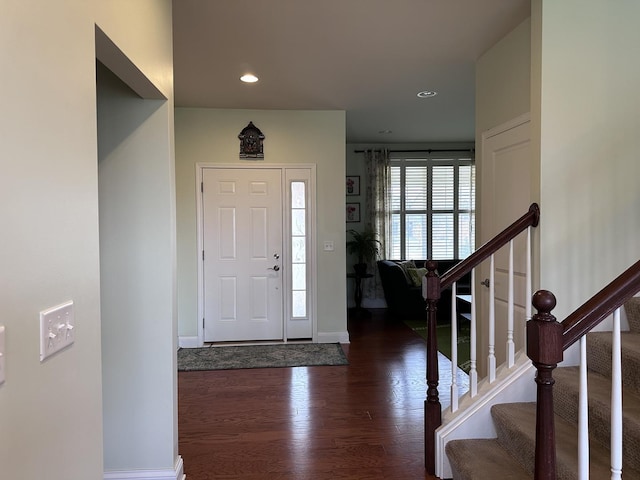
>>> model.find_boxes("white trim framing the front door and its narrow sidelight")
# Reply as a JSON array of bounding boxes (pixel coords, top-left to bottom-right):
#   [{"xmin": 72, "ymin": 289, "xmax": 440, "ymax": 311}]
[{"xmin": 195, "ymin": 162, "xmax": 318, "ymax": 347}]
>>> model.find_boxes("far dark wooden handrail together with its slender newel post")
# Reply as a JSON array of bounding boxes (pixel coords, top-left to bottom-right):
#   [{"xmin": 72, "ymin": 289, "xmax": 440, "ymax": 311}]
[{"xmin": 423, "ymin": 203, "xmax": 540, "ymax": 475}]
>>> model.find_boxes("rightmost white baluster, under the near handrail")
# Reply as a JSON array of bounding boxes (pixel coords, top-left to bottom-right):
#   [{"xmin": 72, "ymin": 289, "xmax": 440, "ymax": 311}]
[{"xmin": 611, "ymin": 308, "xmax": 622, "ymax": 480}]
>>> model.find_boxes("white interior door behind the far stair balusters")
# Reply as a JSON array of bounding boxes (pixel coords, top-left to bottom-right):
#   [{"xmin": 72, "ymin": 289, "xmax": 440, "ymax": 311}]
[{"xmin": 476, "ymin": 115, "xmax": 532, "ymax": 374}]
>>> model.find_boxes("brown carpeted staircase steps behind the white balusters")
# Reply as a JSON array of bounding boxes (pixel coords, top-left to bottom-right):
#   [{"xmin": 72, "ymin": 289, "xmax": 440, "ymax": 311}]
[{"xmin": 446, "ymin": 297, "xmax": 640, "ymax": 480}]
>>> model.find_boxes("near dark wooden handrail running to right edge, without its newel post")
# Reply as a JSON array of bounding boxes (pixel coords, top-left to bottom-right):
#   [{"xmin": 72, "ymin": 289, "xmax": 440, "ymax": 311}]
[{"xmin": 562, "ymin": 260, "xmax": 640, "ymax": 350}]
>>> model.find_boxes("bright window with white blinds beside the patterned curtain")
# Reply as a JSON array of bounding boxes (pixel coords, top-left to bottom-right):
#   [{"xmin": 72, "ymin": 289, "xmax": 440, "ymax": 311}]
[{"xmin": 387, "ymin": 157, "xmax": 476, "ymax": 260}]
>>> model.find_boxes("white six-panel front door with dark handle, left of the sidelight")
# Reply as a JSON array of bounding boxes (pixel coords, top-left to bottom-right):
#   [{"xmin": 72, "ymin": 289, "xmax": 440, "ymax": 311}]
[{"xmin": 202, "ymin": 168, "xmax": 284, "ymax": 342}]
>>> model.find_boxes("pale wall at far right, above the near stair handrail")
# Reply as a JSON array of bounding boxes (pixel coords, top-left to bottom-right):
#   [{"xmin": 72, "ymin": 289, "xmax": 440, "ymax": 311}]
[{"xmin": 534, "ymin": 0, "xmax": 640, "ymax": 319}]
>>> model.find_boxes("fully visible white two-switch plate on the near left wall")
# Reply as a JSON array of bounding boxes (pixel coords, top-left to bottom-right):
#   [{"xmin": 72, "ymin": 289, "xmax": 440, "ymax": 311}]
[{"xmin": 40, "ymin": 301, "xmax": 75, "ymax": 362}]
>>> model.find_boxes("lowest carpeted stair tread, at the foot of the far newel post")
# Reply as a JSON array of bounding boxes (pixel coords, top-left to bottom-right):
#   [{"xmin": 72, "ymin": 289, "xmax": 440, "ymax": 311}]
[{"xmin": 446, "ymin": 439, "xmax": 531, "ymax": 480}]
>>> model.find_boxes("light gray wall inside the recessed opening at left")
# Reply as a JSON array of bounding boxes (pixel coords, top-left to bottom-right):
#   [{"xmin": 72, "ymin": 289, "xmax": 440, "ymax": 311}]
[{"xmin": 97, "ymin": 62, "xmax": 176, "ymax": 471}]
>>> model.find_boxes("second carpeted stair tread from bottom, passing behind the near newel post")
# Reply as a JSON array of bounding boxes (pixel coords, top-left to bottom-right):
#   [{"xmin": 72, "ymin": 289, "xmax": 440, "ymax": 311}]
[{"xmin": 491, "ymin": 403, "xmax": 640, "ymax": 479}]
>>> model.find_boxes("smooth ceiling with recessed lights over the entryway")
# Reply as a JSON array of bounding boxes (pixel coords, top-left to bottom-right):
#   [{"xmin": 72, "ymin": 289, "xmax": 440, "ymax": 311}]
[{"xmin": 173, "ymin": 0, "xmax": 530, "ymax": 143}]
